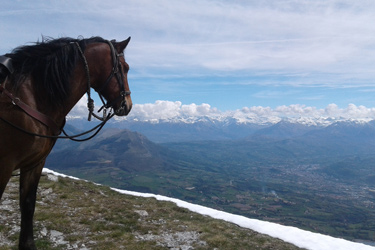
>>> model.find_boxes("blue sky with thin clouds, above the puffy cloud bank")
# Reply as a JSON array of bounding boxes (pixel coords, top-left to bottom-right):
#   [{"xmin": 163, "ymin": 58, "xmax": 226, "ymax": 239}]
[{"xmin": 0, "ymin": 0, "xmax": 375, "ymax": 112}]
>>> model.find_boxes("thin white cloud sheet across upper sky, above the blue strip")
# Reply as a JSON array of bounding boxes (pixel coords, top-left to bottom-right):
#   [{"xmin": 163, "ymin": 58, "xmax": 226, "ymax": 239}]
[{"xmin": 0, "ymin": 0, "xmax": 375, "ymax": 84}]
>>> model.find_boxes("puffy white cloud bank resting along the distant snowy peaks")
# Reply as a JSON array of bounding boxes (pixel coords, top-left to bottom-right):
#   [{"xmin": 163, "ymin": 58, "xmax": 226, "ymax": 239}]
[{"xmin": 69, "ymin": 98, "xmax": 375, "ymax": 123}]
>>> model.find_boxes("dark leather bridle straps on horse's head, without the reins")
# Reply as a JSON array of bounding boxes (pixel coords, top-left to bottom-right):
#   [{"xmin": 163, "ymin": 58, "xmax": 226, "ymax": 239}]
[{"xmin": 75, "ymin": 40, "xmax": 131, "ymax": 121}]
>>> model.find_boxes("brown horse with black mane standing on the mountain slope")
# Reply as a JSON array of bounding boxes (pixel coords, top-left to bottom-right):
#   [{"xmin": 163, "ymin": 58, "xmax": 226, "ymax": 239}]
[{"xmin": 0, "ymin": 37, "xmax": 132, "ymax": 249}]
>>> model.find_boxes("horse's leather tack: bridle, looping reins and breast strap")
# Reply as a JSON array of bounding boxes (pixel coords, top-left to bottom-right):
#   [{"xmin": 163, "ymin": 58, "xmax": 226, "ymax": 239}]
[{"xmin": 0, "ymin": 40, "xmax": 131, "ymax": 142}]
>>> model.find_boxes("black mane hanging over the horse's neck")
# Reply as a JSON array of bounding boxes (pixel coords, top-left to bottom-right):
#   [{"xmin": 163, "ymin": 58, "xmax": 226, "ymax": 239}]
[{"xmin": 6, "ymin": 37, "xmax": 105, "ymax": 107}]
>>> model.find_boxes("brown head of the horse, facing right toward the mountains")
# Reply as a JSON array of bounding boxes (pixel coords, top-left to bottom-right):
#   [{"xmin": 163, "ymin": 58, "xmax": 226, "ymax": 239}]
[{"xmin": 85, "ymin": 37, "xmax": 132, "ymax": 116}]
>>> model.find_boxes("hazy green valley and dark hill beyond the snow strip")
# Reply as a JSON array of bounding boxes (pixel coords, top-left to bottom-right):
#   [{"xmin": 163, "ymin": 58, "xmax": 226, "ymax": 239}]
[{"xmin": 47, "ymin": 118, "xmax": 375, "ymax": 244}]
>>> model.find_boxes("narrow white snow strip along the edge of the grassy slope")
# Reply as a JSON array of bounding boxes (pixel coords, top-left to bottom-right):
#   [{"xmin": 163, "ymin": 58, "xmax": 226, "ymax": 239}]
[{"xmin": 43, "ymin": 168, "xmax": 375, "ymax": 250}]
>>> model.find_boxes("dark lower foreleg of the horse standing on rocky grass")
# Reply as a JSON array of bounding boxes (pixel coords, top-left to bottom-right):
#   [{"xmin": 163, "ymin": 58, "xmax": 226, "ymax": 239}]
[{"xmin": 19, "ymin": 161, "xmax": 45, "ymax": 249}]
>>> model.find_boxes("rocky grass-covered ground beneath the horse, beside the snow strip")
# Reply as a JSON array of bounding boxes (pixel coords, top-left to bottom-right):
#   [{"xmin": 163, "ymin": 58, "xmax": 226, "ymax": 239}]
[{"xmin": 0, "ymin": 175, "xmax": 298, "ymax": 250}]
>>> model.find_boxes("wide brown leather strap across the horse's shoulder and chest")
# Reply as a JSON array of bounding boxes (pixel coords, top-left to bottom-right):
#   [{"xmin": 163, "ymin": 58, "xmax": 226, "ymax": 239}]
[{"xmin": 0, "ymin": 85, "xmax": 61, "ymax": 135}]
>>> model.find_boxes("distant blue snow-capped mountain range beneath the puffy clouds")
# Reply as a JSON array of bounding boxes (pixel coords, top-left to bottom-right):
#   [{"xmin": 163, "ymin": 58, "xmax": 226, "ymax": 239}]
[{"xmin": 68, "ymin": 116, "xmax": 375, "ymax": 143}]
